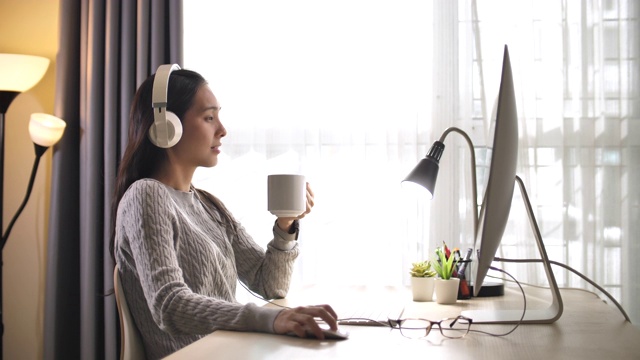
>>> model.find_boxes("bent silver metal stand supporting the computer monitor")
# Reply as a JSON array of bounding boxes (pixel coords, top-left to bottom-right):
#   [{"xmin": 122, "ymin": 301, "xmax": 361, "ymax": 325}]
[{"xmin": 462, "ymin": 176, "xmax": 563, "ymax": 324}]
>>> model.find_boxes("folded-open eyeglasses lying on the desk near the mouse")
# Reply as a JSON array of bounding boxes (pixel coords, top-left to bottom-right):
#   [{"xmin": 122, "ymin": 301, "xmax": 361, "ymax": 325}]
[{"xmin": 389, "ymin": 315, "xmax": 473, "ymax": 339}]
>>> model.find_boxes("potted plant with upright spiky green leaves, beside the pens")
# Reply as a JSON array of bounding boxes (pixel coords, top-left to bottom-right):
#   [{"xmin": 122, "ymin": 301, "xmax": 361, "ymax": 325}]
[{"xmin": 432, "ymin": 242, "xmax": 460, "ymax": 304}]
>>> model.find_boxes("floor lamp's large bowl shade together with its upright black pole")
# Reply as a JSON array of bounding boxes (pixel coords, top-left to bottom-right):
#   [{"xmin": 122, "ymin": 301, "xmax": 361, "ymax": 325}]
[{"xmin": 0, "ymin": 54, "xmax": 49, "ymax": 358}]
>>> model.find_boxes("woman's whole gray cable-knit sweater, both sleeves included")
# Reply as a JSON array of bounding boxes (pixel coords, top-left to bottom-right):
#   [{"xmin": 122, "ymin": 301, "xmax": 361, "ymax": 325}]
[{"xmin": 115, "ymin": 179, "xmax": 298, "ymax": 359}]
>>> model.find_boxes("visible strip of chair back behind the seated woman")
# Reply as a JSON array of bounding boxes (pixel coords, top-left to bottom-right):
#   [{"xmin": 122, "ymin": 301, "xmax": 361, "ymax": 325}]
[{"xmin": 113, "ymin": 265, "xmax": 146, "ymax": 360}]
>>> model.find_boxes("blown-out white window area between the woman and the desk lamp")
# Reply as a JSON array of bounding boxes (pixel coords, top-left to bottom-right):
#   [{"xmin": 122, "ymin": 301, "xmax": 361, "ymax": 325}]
[{"xmin": 184, "ymin": 0, "xmax": 432, "ymax": 284}]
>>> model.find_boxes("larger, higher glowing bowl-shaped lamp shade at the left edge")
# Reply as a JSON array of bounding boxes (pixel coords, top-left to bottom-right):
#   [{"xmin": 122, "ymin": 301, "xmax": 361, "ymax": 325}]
[{"xmin": 0, "ymin": 54, "xmax": 49, "ymax": 92}]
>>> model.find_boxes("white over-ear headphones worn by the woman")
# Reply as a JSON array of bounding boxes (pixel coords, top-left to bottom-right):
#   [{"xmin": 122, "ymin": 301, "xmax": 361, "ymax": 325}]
[{"xmin": 149, "ymin": 64, "xmax": 182, "ymax": 149}]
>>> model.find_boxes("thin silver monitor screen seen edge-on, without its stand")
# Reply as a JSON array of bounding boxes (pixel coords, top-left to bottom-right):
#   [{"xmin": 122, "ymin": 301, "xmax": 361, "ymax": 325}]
[{"xmin": 473, "ymin": 45, "xmax": 518, "ymax": 296}]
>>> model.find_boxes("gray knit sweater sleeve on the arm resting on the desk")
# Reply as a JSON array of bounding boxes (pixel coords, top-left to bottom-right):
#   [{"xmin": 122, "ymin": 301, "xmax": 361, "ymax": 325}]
[{"xmin": 118, "ymin": 181, "xmax": 280, "ymax": 334}]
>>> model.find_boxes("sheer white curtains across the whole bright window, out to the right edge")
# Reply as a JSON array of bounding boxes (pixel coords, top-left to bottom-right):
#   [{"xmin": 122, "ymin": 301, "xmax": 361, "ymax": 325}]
[{"xmin": 184, "ymin": 0, "xmax": 640, "ymax": 319}]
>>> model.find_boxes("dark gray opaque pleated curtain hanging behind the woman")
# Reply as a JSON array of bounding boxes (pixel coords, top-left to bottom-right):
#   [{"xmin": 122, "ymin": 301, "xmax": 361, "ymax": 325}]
[{"xmin": 44, "ymin": 0, "xmax": 182, "ymax": 359}]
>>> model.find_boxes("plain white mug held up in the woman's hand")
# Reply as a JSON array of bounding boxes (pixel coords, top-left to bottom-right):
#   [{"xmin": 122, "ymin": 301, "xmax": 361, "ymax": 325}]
[{"xmin": 267, "ymin": 174, "xmax": 307, "ymax": 217}]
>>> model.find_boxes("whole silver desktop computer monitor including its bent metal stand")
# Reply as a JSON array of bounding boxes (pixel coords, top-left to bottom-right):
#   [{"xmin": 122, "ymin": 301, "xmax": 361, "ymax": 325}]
[{"xmin": 465, "ymin": 45, "xmax": 562, "ymax": 323}]
